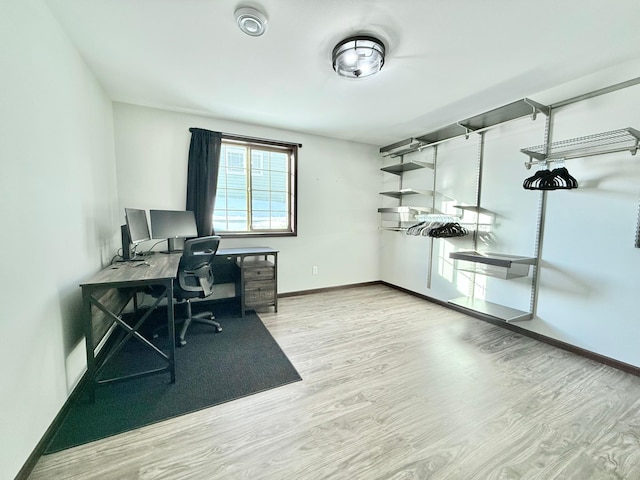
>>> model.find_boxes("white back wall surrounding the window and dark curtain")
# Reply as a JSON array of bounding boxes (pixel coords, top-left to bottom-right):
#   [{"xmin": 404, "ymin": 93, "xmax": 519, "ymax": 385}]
[{"xmin": 114, "ymin": 103, "xmax": 381, "ymax": 293}]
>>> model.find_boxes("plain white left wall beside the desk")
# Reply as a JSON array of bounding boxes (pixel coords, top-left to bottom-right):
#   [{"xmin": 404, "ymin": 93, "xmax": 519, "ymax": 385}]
[{"xmin": 0, "ymin": 0, "xmax": 117, "ymax": 478}]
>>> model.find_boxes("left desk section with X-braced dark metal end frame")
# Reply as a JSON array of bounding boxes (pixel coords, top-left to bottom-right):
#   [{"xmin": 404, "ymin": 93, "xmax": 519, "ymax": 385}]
[{"xmin": 80, "ymin": 253, "xmax": 181, "ymax": 398}]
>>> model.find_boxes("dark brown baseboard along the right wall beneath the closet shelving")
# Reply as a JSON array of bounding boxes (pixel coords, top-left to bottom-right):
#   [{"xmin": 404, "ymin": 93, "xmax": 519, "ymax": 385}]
[{"xmin": 380, "ymin": 281, "xmax": 640, "ymax": 377}]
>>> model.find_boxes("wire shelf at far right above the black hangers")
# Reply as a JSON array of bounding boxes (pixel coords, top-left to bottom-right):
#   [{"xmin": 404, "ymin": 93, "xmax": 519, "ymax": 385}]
[{"xmin": 520, "ymin": 127, "xmax": 640, "ymax": 168}]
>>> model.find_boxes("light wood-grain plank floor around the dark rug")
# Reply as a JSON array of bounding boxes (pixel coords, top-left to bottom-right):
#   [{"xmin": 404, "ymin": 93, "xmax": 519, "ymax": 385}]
[{"xmin": 30, "ymin": 285, "xmax": 640, "ymax": 480}]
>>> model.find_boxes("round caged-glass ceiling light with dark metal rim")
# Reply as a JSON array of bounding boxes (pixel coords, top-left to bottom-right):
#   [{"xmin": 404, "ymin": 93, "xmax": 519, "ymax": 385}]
[{"xmin": 331, "ymin": 35, "xmax": 385, "ymax": 78}]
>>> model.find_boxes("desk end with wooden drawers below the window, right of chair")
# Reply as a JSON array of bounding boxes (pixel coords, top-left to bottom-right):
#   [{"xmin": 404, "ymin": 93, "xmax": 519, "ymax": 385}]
[{"xmin": 216, "ymin": 247, "xmax": 278, "ymax": 317}]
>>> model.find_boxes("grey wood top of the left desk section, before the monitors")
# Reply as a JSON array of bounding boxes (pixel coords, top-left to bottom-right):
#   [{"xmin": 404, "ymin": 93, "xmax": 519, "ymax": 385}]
[{"xmin": 80, "ymin": 253, "xmax": 182, "ymax": 287}]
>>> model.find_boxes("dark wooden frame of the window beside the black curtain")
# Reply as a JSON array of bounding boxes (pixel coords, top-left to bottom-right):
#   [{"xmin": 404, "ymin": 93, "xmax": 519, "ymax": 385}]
[{"xmin": 212, "ymin": 134, "xmax": 302, "ymax": 238}]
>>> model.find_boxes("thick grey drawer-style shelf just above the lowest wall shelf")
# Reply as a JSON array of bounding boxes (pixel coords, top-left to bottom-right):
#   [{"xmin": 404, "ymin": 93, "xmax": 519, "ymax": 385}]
[{"xmin": 449, "ymin": 251, "xmax": 537, "ymax": 280}]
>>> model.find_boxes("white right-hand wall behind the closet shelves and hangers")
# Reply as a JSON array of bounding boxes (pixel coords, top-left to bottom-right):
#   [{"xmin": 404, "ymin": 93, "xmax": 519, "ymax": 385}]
[{"xmin": 381, "ymin": 76, "xmax": 640, "ymax": 366}]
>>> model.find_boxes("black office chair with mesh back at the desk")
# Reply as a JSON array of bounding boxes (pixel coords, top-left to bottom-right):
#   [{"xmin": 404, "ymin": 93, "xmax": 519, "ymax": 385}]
[{"xmin": 168, "ymin": 235, "xmax": 222, "ymax": 346}]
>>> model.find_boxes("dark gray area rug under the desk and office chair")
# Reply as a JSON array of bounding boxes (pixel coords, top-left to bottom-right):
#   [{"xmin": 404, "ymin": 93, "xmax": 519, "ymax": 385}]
[{"xmin": 45, "ymin": 304, "xmax": 301, "ymax": 453}]
